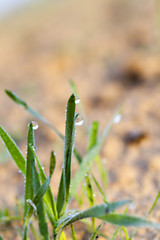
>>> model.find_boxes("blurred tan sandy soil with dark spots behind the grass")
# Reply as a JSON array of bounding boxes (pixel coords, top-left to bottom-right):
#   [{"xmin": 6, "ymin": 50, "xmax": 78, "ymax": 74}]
[{"xmin": 0, "ymin": 0, "xmax": 160, "ymax": 239}]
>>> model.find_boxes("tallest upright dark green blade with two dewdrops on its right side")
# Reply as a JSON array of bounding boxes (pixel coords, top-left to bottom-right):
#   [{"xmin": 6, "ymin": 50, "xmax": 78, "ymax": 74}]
[{"xmin": 57, "ymin": 94, "xmax": 75, "ymax": 216}]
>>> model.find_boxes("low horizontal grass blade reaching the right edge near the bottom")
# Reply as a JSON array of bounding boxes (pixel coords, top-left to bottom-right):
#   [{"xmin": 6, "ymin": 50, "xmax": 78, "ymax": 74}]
[{"xmin": 98, "ymin": 213, "xmax": 160, "ymax": 230}]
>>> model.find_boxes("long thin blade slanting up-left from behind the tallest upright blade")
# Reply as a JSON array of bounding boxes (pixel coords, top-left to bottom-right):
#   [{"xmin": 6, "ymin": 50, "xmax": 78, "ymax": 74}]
[{"xmin": 5, "ymin": 90, "xmax": 82, "ymax": 163}]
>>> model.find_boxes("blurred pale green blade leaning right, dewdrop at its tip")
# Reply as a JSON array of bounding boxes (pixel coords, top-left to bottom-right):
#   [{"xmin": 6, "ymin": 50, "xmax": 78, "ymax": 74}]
[{"xmin": 70, "ymin": 109, "xmax": 120, "ymax": 197}]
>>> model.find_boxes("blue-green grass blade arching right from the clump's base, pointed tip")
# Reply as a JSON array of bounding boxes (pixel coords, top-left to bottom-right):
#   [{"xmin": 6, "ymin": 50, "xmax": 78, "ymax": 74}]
[{"xmin": 56, "ymin": 200, "xmax": 131, "ymax": 239}]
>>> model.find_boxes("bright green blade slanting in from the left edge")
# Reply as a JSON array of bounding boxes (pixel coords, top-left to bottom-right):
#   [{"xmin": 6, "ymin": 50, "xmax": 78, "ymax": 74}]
[{"xmin": 0, "ymin": 126, "xmax": 25, "ymax": 175}]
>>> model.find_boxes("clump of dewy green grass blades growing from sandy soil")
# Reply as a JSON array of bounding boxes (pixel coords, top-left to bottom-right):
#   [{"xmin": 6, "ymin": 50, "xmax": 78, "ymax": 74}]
[{"xmin": 0, "ymin": 86, "xmax": 160, "ymax": 240}]
